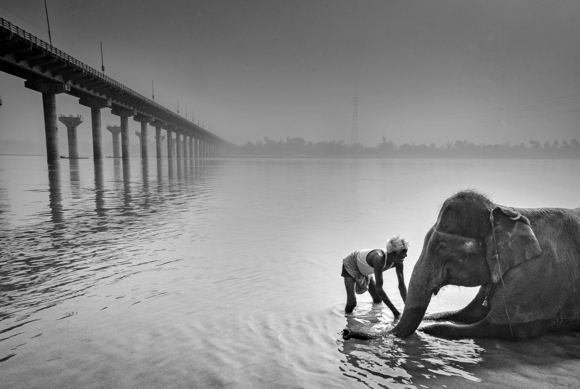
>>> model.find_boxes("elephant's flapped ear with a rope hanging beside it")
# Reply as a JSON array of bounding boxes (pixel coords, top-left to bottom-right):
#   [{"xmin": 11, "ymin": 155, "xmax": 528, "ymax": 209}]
[{"xmin": 490, "ymin": 207, "xmax": 542, "ymax": 283}]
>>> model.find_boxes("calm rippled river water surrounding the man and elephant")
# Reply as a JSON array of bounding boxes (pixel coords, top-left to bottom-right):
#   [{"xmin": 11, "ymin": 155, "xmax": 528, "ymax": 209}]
[{"xmin": 0, "ymin": 156, "xmax": 580, "ymax": 388}]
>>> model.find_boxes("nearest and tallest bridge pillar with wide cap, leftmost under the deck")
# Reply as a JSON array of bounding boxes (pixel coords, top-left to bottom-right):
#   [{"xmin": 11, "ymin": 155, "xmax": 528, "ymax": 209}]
[{"xmin": 24, "ymin": 80, "xmax": 70, "ymax": 161}]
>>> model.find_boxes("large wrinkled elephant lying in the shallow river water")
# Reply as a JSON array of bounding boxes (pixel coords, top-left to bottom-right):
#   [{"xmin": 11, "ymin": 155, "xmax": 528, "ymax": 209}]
[{"xmin": 345, "ymin": 191, "xmax": 580, "ymax": 340}]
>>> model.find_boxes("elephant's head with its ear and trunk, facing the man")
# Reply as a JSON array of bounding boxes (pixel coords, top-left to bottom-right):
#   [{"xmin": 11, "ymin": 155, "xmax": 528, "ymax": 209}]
[{"xmin": 391, "ymin": 191, "xmax": 541, "ymax": 337}]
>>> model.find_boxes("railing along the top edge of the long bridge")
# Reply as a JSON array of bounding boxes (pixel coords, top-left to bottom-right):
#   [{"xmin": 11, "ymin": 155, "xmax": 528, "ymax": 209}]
[{"xmin": 0, "ymin": 17, "xmax": 209, "ymax": 137}]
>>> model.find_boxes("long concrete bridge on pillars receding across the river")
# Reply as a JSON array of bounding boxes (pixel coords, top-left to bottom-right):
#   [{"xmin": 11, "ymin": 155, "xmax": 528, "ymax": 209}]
[{"xmin": 0, "ymin": 18, "xmax": 227, "ymax": 162}]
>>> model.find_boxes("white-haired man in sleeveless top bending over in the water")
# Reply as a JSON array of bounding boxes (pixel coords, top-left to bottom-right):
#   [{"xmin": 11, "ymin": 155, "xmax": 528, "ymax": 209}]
[{"xmin": 341, "ymin": 236, "xmax": 409, "ymax": 318}]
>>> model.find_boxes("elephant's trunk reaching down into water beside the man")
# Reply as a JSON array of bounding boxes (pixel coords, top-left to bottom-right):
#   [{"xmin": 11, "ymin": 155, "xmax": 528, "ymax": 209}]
[{"xmin": 390, "ymin": 258, "xmax": 438, "ymax": 338}]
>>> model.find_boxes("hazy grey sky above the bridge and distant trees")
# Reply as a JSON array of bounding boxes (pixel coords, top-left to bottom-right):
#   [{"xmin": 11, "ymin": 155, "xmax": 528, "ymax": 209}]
[{"xmin": 0, "ymin": 0, "xmax": 580, "ymax": 146}]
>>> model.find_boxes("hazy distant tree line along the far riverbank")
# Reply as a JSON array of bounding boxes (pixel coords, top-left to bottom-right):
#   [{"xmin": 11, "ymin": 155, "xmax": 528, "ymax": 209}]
[{"xmin": 228, "ymin": 137, "xmax": 580, "ymax": 159}]
